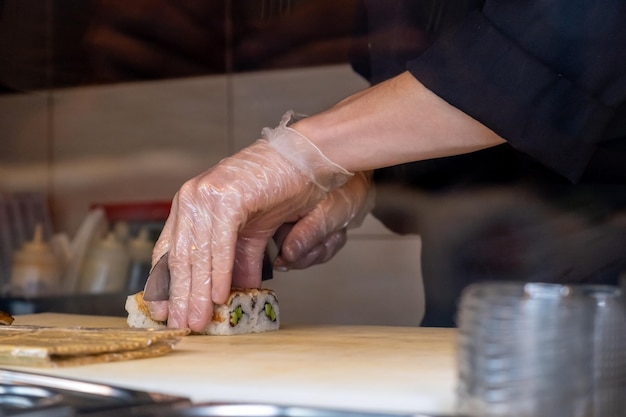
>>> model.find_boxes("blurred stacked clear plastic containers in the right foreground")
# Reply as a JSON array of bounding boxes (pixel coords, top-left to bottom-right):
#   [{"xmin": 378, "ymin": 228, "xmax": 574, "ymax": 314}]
[{"xmin": 457, "ymin": 283, "xmax": 626, "ymax": 417}]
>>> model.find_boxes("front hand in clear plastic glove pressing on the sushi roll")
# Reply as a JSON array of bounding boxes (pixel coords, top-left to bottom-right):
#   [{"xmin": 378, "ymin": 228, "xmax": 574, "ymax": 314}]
[{"xmin": 148, "ymin": 112, "xmax": 352, "ymax": 331}]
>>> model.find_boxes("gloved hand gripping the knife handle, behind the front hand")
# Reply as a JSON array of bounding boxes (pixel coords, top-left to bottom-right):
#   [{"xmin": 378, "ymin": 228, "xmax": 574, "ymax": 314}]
[{"xmin": 274, "ymin": 172, "xmax": 374, "ymax": 270}]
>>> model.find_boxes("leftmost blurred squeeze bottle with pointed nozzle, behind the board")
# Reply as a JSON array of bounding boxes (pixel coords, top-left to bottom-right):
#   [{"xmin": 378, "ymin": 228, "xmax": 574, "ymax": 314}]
[{"xmin": 11, "ymin": 224, "xmax": 62, "ymax": 297}]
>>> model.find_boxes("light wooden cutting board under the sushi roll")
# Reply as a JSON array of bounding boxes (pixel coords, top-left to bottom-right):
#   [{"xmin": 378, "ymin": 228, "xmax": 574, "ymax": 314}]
[{"xmin": 4, "ymin": 313, "xmax": 456, "ymax": 413}]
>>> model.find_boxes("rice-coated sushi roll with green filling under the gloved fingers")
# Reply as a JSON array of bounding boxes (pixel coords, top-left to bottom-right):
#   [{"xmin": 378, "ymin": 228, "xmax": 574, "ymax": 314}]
[{"xmin": 126, "ymin": 288, "xmax": 280, "ymax": 336}]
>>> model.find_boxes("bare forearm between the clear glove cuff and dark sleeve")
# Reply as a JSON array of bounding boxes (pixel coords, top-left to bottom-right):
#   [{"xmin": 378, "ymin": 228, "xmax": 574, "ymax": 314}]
[{"xmin": 291, "ymin": 73, "xmax": 504, "ymax": 171}]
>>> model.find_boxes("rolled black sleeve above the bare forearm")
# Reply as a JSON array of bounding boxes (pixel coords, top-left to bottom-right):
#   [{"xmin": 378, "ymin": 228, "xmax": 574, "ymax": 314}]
[{"xmin": 407, "ymin": 0, "xmax": 626, "ymax": 182}]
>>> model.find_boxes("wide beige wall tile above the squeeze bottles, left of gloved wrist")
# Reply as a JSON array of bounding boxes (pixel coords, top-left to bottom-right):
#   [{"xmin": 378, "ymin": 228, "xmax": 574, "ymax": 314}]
[{"xmin": 53, "ymin": 77, "xmax": 228, "ymax": 232}]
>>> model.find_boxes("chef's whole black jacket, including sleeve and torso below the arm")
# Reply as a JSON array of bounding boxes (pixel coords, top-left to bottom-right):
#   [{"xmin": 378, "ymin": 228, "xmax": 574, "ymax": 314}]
[{"xmin": 352, "ymin": 0, "xmax": 626, "ymax": 326}]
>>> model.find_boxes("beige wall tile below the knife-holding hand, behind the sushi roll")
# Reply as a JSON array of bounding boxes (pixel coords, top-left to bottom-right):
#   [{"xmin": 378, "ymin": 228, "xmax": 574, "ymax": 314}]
[{"xmin": 264, "ymin": 217, "xmax": 424, "ymax": 326}]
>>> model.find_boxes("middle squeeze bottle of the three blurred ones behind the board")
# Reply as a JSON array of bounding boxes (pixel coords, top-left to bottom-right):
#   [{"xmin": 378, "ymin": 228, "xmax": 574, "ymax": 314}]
[{"xmin": 79, "ymin": 232, "xmax": 129, "ymax": 294}]
